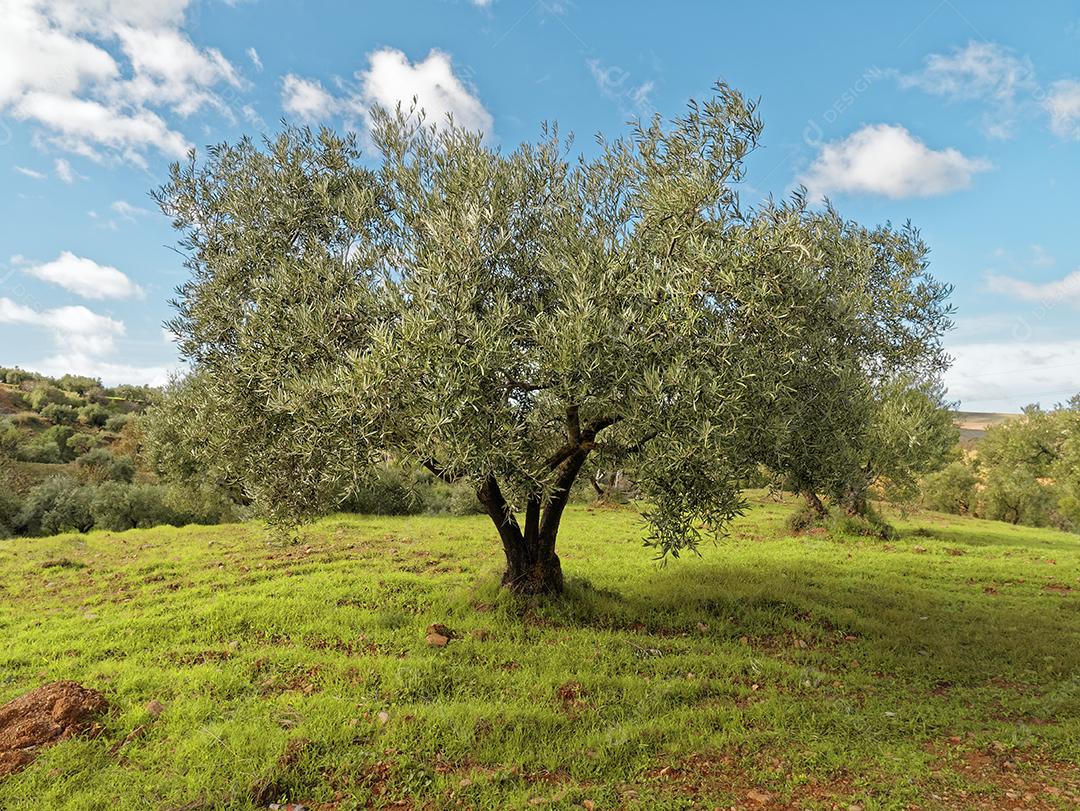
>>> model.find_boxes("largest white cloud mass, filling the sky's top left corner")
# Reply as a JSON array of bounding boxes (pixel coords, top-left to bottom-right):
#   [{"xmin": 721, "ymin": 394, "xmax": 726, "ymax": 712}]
[{"xmin": 0, "ymin": 0, "xmax": 244, "ymax": 165}]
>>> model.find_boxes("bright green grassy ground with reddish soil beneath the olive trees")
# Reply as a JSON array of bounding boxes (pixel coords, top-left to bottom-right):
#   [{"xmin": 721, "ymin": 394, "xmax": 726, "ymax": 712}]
[{"xmin": 0, "ymin": 497, "xmax": 1080, "ymax": 811}]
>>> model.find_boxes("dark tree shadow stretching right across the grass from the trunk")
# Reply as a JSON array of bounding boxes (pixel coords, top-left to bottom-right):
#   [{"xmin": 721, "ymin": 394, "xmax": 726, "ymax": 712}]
[{"xmin": 540, "ymin": 558, "xmax": 1080, "ymax": 709}]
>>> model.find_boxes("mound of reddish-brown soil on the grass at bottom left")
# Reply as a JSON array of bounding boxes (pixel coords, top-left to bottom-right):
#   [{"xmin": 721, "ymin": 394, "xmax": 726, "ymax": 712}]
[{"xmin": 0, "ymin": 681, "xmax": 108, "ymax": 778}]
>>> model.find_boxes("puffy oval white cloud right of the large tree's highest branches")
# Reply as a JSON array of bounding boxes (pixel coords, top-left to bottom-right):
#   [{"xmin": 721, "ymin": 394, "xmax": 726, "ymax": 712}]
[{"xmin": 799, "ymin": 124, "xmax": 990, "ymax": 199}]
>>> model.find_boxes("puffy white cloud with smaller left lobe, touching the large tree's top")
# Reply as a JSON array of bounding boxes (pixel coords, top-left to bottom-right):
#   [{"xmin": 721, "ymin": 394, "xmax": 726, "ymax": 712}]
[{"xmin": 282, "ymin": 48, "xmax": 495, "ymax": 138}]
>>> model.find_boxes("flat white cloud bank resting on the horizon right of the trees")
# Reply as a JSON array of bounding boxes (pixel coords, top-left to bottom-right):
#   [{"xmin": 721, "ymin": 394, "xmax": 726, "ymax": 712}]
[{"xmin": 945, "ymin": 340, "xmax": 1080, "ymax": 411}]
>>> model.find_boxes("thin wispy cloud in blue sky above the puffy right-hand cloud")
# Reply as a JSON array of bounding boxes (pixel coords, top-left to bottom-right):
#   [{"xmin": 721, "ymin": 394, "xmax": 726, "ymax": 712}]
[{"xmin": 900, "ymin": 42, "xmax": 1038, "ymax": 138}]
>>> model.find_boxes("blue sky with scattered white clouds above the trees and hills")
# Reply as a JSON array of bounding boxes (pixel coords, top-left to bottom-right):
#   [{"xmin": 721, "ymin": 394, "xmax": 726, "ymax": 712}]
[{"xmin": 0, "ymin": 0, "xmax": 1080, "ymax": 410}]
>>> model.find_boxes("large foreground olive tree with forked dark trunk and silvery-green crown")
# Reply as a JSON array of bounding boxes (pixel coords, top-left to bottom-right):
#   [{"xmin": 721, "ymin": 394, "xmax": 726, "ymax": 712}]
[{"xmin": 147, "ymin": 84, "xmax": 954, "ymax": 593}]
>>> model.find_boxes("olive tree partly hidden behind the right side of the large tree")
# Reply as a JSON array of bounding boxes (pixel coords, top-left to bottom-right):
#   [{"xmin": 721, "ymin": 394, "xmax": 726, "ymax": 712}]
[{"xmin": 748, "ymin": 194, "xmax": 956, "ymax": 518}]
